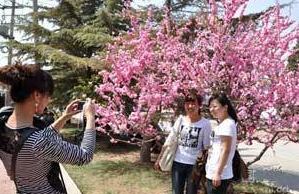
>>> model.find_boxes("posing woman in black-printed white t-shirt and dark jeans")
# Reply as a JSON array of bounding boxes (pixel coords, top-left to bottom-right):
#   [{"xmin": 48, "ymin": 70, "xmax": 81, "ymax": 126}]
[{"xmin": 155, "ymin": 94, "xmax": 211, "ymax": 194}]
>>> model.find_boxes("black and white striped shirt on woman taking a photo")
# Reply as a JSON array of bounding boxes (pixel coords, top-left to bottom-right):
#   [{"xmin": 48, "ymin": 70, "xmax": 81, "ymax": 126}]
[{"xmin": 0, "ymin": 126, "xmax": 96, "ymax": 194}]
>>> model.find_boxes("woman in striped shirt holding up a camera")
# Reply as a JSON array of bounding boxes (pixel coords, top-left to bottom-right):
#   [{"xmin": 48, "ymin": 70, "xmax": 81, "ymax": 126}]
[{"xmin": 0, "ymin": 65, "xmax": 96, "ymax": 194}]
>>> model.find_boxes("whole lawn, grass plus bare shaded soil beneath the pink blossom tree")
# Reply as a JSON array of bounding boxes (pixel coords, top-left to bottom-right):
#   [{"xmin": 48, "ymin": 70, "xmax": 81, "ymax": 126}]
[{"xmin": 62, "ymin": 128, "xmax": 290, "ymax": 194}]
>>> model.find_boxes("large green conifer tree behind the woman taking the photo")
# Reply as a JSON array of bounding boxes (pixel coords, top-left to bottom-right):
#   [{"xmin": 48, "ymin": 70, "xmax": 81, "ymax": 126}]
[{"xmin": 10, "ymin": 0, "xmax": 128, "ymax": 105}]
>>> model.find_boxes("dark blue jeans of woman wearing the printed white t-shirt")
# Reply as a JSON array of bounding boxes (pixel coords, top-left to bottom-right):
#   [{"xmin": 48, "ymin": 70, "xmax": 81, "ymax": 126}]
[{"xmin": 171, "ymin": 161, "xmax": 198, "ymax": 194}]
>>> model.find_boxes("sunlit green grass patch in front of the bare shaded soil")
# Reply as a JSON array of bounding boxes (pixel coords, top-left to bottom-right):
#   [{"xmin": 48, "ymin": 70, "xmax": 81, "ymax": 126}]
[{"xmin": 66, "ymin": 160, "xmax": 170, "ymax": 194}]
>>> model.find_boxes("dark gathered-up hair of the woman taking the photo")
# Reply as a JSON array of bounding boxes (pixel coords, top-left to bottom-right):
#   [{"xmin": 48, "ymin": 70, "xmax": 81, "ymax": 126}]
[{"xmin": 0, "ymin": 64, "xmax": 54, "ymax": 103}]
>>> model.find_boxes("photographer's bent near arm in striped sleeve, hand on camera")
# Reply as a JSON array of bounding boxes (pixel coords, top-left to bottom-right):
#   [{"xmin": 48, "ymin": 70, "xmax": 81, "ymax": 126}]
[{"xmin": 32, "ymin": 100, "xmax": 96, "ymax": 165}]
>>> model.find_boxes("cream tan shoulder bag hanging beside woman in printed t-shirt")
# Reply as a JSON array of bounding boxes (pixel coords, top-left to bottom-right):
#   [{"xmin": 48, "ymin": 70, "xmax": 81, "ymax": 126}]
[{"xmin": 159, "ymin": 116, "xmax": 183, "ymax": 171}]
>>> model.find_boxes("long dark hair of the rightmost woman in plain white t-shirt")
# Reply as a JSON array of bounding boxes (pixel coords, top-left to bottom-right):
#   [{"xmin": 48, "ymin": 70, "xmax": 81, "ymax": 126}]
[{"xmin": 209, "ymin": 93, "xmax": 238, "ymax": 122}]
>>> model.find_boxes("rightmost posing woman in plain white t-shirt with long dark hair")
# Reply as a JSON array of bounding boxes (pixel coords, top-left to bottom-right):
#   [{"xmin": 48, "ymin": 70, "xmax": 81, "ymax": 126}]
[{"xmin": 206, "ymin": 94, "xmax": 238, "ymax": 194}]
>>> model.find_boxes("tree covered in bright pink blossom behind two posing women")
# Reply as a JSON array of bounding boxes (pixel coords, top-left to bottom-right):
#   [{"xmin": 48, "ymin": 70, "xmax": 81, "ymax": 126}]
[{"xmin": 96, "ymin": 0, "xmax": 299, "ymax": 165}]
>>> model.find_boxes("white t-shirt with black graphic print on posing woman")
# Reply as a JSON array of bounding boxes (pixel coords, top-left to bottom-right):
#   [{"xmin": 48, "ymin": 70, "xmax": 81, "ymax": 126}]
[{"xmin": 165, "ymin": 116, "xmax": 211, "ymax": 165}]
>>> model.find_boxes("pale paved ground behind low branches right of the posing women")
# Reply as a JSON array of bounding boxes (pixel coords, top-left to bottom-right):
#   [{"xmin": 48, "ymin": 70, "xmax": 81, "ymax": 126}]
[{"xmin": 238, "ymin": 141, "xmax": 299, "ymax": 194}]
